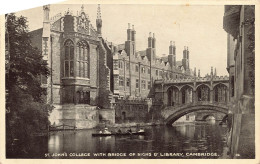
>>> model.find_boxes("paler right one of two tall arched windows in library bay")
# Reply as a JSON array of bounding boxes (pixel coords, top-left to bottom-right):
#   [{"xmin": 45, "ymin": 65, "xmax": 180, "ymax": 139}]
[{"xmin": 77, "ymin": 41, "xmax": 89, "ymax": 78}]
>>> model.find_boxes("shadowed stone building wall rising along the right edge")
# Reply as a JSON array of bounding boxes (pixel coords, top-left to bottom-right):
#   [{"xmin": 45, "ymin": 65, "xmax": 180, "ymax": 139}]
[{"xmin": 223, "ymin": 5, "xmax": 255, "ymax": 158}]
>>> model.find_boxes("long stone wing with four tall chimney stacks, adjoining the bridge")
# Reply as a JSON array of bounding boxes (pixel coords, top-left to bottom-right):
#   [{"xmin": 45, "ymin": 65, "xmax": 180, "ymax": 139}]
[{"xmin": 112, "ymin": 24, "xmax": 193, "ymax": 122}]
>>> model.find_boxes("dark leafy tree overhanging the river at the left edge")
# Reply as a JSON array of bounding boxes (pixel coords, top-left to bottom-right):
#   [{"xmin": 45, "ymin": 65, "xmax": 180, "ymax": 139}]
[{"xmin": 5, "ymin": 14, "xmax": 52, "ymax": 156}]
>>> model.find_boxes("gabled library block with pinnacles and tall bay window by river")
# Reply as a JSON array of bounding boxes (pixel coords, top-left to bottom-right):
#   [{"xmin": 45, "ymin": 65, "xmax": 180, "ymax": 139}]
[{"xmin": 31, "ymin": 5, "xmax": 114, "ymax": 128}]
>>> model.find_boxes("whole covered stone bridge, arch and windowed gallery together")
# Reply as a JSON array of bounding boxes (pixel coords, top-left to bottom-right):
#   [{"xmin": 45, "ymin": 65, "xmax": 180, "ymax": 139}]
[{"xmin": 154, "ymin": 75, "xmax": 229, "ymax": 124}]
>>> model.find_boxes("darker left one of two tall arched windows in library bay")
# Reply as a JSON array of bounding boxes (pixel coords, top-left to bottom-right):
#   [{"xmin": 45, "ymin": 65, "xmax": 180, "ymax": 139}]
[{"xmin": 64, "ymin": 40, "xmax": 74, "ymax": 77}]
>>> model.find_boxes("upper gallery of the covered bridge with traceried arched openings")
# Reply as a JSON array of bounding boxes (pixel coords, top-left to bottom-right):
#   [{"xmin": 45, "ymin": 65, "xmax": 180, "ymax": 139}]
[{"xmin": 154, "ymin": 76, "xmax": 229, "ymax": 106}]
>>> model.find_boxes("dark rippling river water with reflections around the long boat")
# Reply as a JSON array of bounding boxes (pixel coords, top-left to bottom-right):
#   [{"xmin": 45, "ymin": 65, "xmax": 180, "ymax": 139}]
[{"xmin": 11, "ymin": 123, "xmax": 226, "ymax": 158}]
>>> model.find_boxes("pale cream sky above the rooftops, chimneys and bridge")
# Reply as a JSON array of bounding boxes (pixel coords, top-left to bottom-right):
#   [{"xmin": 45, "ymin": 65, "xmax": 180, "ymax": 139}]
[{"xmin": 16, "ymin": 4, "xmax": 228, "ymax": 76}]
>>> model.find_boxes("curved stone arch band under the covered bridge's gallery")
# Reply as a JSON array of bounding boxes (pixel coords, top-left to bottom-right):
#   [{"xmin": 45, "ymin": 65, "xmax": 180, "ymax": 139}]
[{"xmin": 165, "ymin": 105, "xmax": 228, "ymax": 125}]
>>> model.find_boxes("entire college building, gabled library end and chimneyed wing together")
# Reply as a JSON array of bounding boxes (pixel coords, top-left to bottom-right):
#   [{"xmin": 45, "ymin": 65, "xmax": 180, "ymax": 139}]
[{"xmin": 30, "ymin": 5, "xmax": 197, "ymax": 125}]
